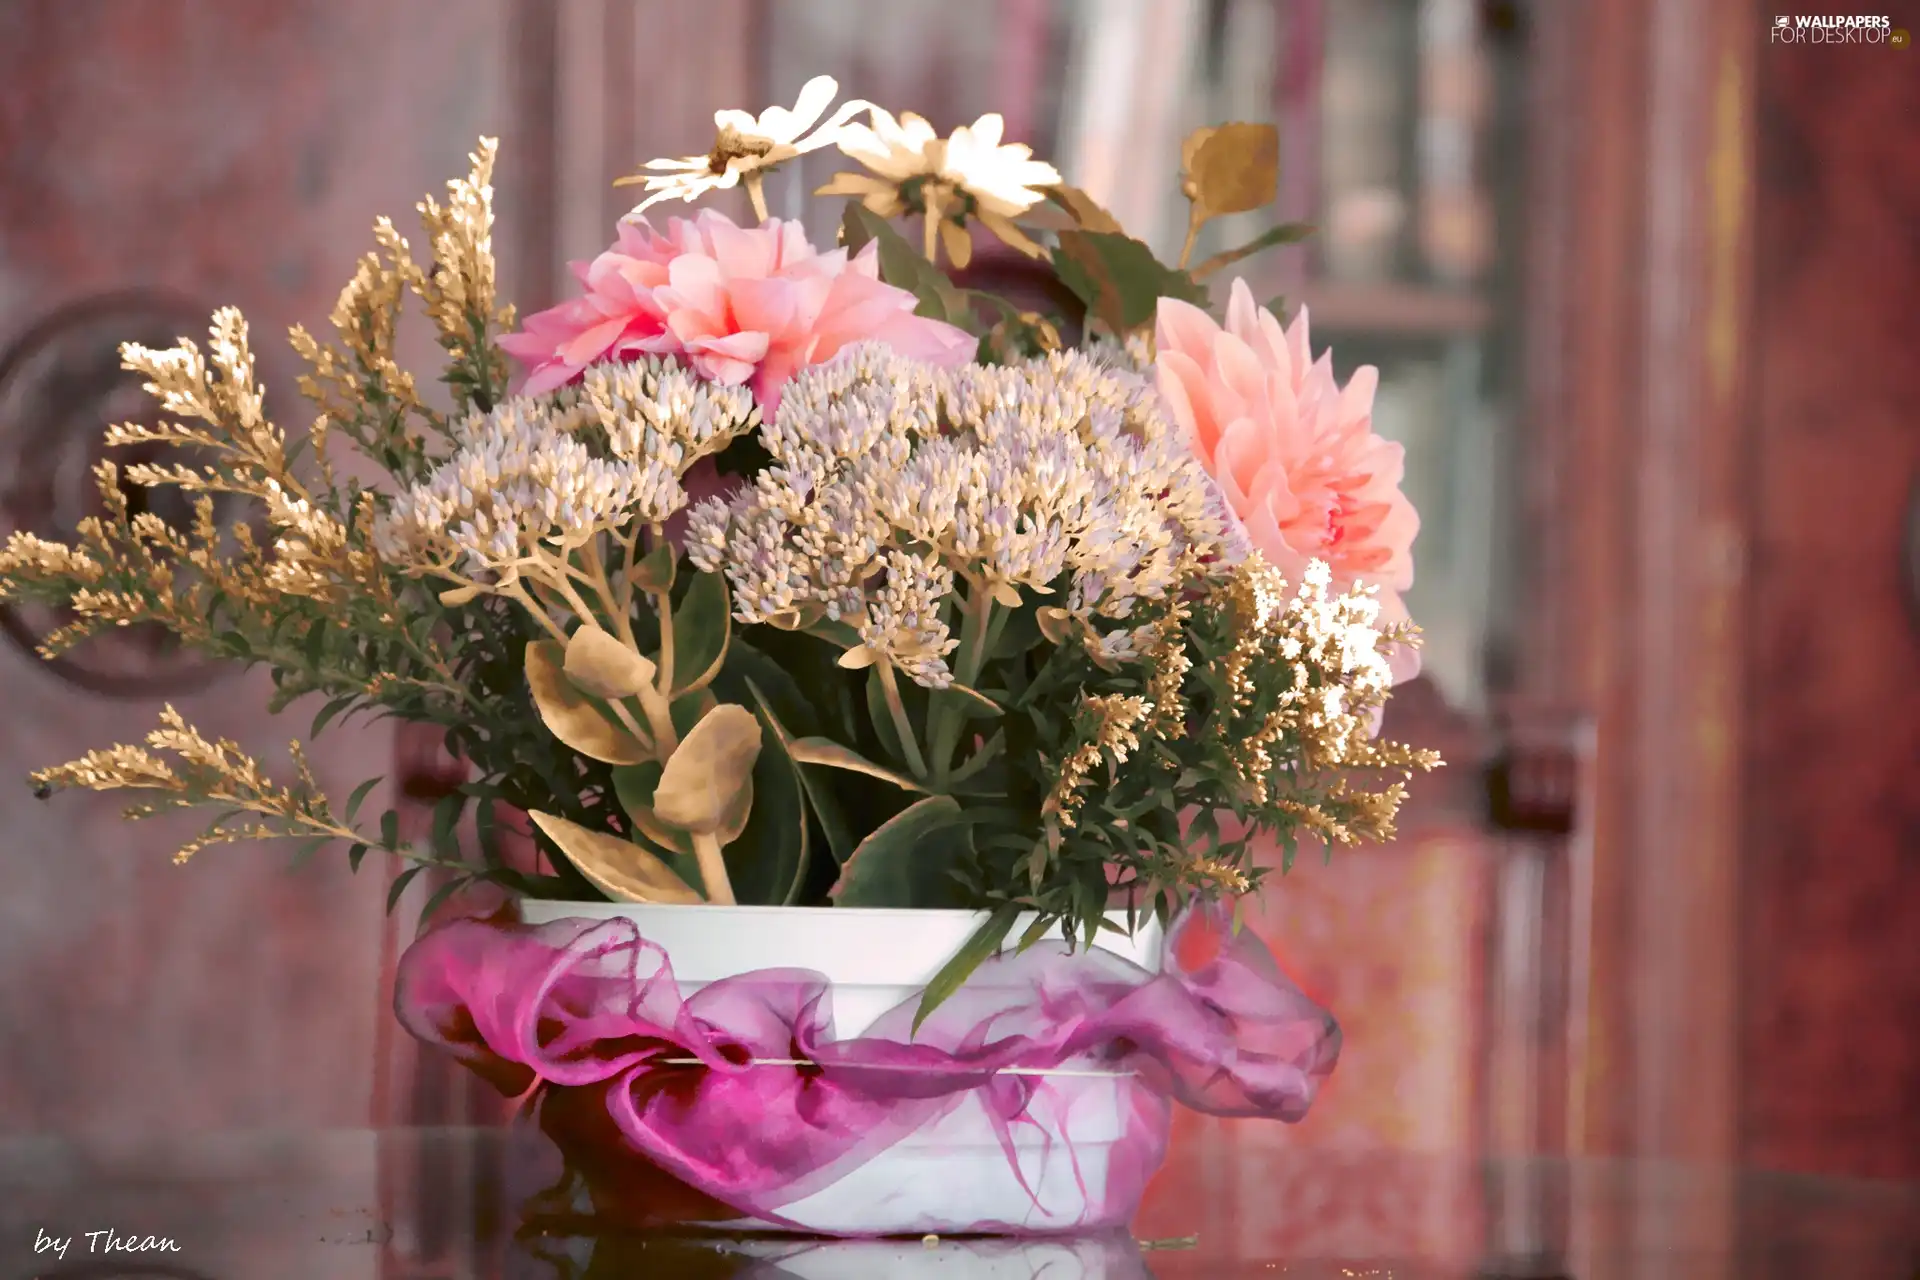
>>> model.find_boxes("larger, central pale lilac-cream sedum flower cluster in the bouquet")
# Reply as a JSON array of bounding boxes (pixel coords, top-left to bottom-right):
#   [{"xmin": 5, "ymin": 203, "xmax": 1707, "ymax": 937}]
[{"xmin": 687, "ymin": 345, "xmax": 1240, "ymax": 689}]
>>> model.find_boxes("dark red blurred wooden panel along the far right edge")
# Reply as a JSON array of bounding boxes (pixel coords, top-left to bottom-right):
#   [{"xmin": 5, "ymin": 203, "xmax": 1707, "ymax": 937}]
[{"xmin": 1740, "ymin": 12, "xmax": 1920, "ymax": 1189}]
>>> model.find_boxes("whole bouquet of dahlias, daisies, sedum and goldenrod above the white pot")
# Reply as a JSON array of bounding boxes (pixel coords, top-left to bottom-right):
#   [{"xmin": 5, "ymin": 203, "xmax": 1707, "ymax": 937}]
[{"xmin": 0, "ymin": 77, "xmax": 1438, "ymax": 1013}]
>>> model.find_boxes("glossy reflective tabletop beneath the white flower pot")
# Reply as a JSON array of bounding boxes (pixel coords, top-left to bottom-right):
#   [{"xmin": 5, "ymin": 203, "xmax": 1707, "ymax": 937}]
[{"xmin": 0, "ymin": 1123, "xmax": 1920, "ymax": 1280}]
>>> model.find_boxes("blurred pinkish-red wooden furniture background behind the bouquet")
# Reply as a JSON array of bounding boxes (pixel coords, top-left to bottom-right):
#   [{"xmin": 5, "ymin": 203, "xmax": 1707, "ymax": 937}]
[{"xmin": 0, "ymin": 0, "xmax": 1920, "ymax": 1257}]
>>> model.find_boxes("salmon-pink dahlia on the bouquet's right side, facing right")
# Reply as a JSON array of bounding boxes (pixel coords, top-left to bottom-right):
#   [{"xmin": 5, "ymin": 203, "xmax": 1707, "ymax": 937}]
[{"xmin": 1154, "ymin": 280, "xmax": 1421, "ymax": 679}]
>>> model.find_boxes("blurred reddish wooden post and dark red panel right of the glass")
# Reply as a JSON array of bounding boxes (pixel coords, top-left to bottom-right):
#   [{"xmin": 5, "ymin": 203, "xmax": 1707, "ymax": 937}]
[{"xmin": 1523, "ymin": 0, "xmax": 1920, "ymax": 1205}]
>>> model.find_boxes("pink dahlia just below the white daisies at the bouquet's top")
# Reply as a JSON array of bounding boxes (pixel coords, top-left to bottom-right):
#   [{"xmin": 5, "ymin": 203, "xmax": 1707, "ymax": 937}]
[{"xmin": 501, "ymin": 209, "xmax": 975, "ymax": 415}]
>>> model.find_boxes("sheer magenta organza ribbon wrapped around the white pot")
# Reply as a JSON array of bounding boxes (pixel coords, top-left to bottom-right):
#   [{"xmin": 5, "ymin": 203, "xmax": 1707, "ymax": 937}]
[{"xmin": 394, "ymin": 910, "xmax": 1340, "ymax": 1230}]
